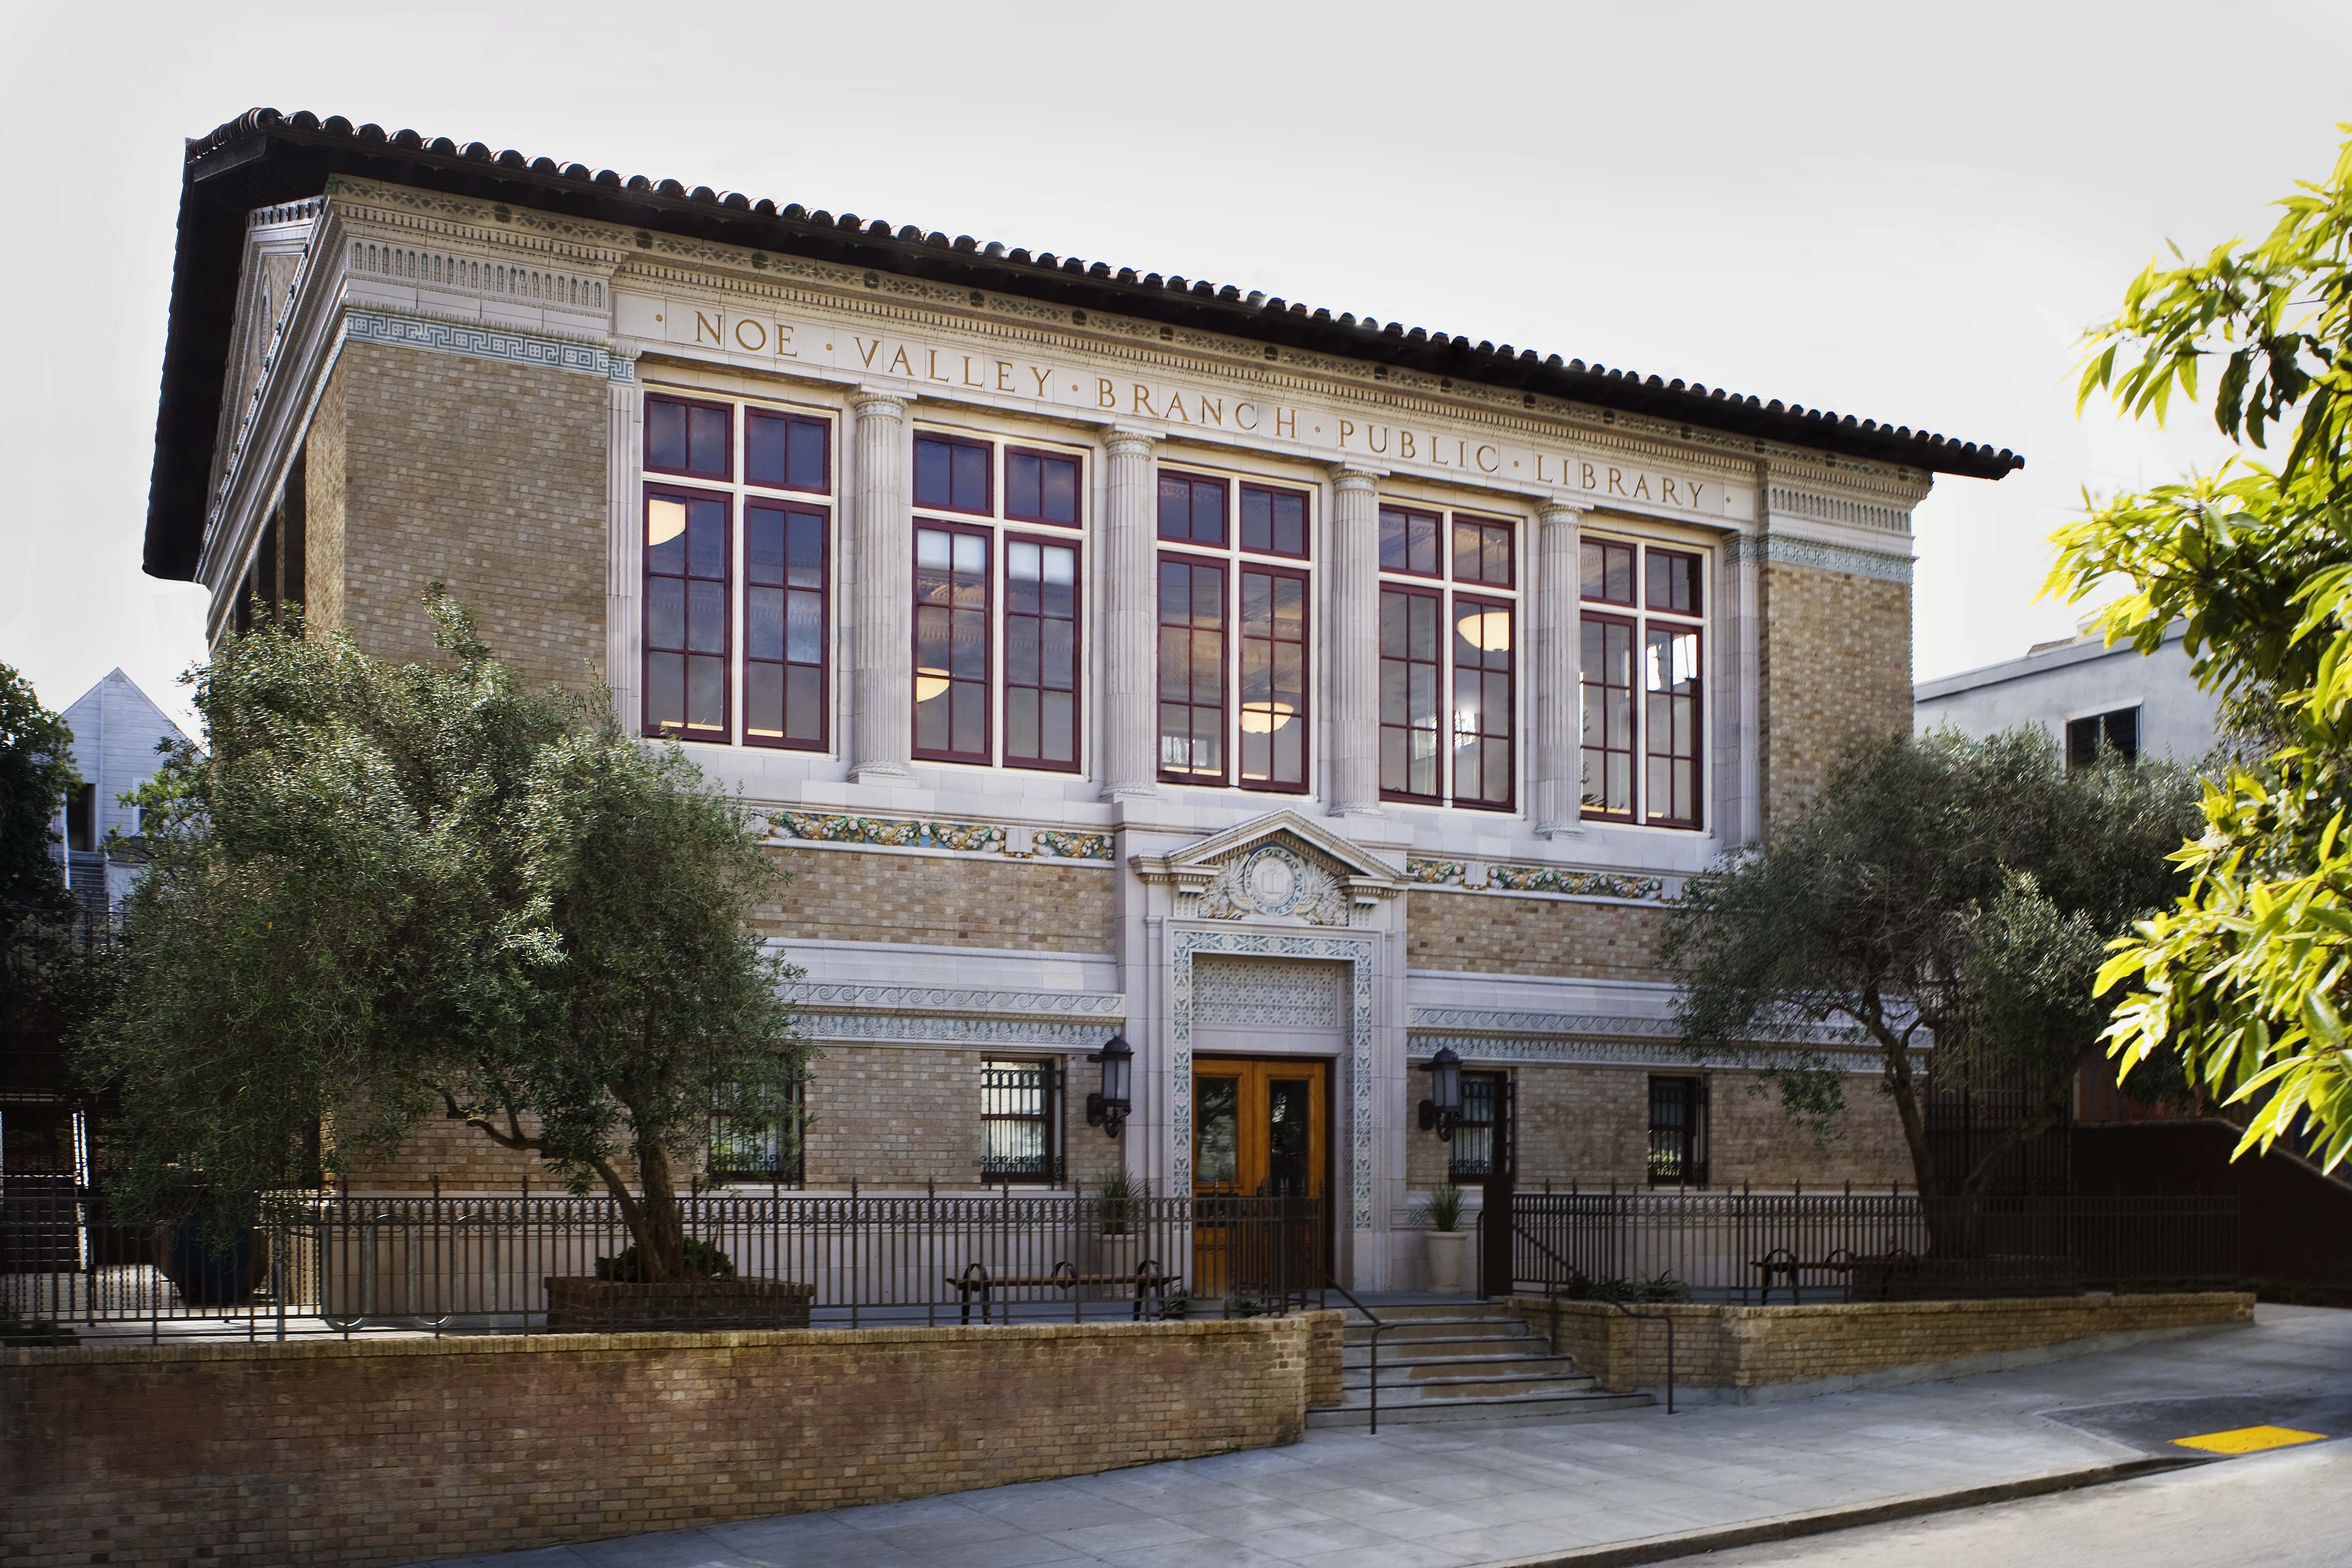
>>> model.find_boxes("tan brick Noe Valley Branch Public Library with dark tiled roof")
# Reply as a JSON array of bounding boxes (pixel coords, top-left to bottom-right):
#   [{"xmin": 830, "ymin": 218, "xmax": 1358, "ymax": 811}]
[{"xmin": 146, "ymin": 111, "xmax": 2020, "ymax": 1286}]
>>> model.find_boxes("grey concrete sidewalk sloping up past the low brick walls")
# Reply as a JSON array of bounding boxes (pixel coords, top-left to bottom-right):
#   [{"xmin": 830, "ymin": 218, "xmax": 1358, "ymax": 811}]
[{"xmin": 409, "ymin": 1307, "xmax": 2352, "ymax": 1568}]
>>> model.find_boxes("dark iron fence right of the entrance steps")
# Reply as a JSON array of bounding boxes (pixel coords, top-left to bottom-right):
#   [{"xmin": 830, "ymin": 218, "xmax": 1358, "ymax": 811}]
[{"xmin": 1510, "ymin": 1192, "xmax": 2239, "ymax": 1305}]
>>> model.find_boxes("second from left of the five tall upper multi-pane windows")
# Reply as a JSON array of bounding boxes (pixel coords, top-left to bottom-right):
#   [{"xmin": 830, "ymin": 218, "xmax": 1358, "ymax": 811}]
[{"xmin": 913, "ymin": 430, "xmax": 1086, "ymax": 774}]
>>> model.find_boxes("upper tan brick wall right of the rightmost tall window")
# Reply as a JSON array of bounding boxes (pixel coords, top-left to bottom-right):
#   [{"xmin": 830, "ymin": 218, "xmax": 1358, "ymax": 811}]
[{"xmin": 1757, "ymin": 562, "xmax": 1912, "ymax": 832}]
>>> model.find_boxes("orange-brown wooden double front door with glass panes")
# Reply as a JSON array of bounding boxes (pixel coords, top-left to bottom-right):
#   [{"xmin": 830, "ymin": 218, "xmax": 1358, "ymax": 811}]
[{"xmin": 1192, "ymin": 1058, "xmax": 1331, "ymax": 1295}]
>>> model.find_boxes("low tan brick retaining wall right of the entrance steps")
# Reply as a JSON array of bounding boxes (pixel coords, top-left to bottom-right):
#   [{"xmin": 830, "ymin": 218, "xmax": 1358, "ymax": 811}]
[{"xmin": 1512, "ymin": 1290, "xmax": 2253, "ymax": 1389}]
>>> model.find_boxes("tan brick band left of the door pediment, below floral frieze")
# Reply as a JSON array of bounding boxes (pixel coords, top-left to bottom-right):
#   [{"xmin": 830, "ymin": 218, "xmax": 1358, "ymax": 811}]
[{"xmin": 752, "ymin": 849, "xmax": 1117, "ymax": 952}]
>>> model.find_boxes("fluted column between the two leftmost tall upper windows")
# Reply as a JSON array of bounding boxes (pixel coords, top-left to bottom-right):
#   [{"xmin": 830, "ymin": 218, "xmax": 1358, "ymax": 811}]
[{"xmin": 844, "ymin": 390, "xmax": 915, "ymax": 783}]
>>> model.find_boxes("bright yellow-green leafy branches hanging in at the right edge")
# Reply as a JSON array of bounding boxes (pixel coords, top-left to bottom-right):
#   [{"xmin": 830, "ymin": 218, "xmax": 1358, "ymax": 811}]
[{"xmin": 2049, "ymin": 124, "xmax": 2352, "ymax": 1166}]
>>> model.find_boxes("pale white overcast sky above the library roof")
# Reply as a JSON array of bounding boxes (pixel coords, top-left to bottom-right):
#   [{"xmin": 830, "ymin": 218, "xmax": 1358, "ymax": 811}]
[{"xmin": 0, "ymin": 0, "xmax": 2352, "ymax": 715}]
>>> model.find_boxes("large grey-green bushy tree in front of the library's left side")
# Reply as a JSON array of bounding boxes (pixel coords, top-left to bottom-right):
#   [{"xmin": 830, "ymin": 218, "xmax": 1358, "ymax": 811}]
[{"xmin": 87, "ymin": 590, "xmax": 807, "ymax": 1281}]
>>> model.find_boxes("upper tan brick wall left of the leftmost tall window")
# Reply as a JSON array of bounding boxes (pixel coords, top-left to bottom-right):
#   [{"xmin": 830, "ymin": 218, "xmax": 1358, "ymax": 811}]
[{"xmin": 306, "ymin": 343, "xmax": 609, "ymax": 689}]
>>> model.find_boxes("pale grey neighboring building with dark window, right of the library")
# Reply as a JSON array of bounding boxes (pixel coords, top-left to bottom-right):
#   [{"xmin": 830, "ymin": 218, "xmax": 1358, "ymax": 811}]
[{"xmin": 1912, "ymin": 625, "xmax": 2220, "ymax": 767}]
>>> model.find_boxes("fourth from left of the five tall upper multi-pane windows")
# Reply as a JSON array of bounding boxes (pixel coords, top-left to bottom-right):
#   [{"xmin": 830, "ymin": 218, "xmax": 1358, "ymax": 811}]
[{"xmin": 1380, "ymin": 506, "xmax": 1519, "ymax": 811}]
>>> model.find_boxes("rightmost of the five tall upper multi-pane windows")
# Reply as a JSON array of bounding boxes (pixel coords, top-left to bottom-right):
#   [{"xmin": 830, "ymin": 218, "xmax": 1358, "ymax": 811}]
[{"xmin": 1581, "ymin": 539, "xmax": 1705, "ymax": 827}]
